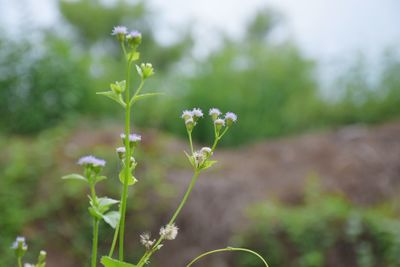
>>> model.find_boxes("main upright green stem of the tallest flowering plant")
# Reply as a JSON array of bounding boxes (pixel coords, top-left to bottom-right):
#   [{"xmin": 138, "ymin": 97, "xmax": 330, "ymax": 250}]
[{"xmin": 119, "ymin": 60, "xmax": 132, "ymax": 261}]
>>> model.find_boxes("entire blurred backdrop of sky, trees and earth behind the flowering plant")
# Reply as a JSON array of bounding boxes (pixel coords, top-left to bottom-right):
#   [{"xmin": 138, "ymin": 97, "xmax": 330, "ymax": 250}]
[{"xmin": 0, "ymin": 0, "xmax": 400, "ymax": 267}]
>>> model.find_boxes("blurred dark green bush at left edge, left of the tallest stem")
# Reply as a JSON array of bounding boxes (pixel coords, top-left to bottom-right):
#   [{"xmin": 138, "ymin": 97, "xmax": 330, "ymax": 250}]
[{"xmin": 0, "ymin": 34, "xmax": 93, "ymax": 134}]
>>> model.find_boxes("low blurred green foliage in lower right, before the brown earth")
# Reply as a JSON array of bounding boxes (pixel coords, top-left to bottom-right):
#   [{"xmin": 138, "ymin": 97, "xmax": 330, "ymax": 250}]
[{"xmin": 237, "ymin": 178, "xmax": 400, "ymax": 267}]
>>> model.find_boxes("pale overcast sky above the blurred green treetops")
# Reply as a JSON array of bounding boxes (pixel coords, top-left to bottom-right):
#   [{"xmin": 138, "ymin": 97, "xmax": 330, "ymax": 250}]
[{"xmin": 0, "ymin": 0, "xmax": 400, "ymax": 65}]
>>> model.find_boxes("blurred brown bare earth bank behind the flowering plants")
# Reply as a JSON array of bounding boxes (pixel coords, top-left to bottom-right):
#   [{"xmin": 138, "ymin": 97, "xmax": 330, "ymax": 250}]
[{"xmin": 49, "ymin": 121, "xmax": 400, "ymax": 267}]
